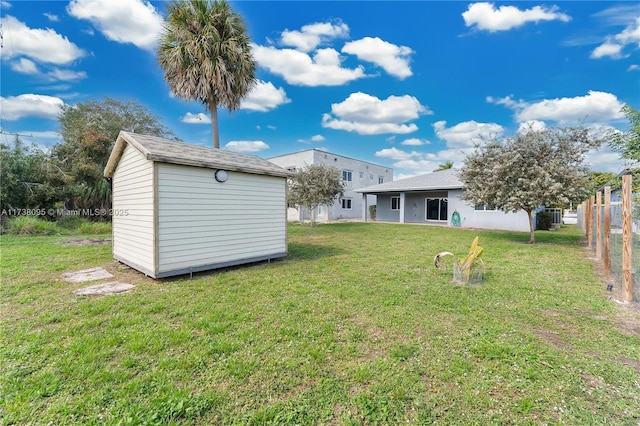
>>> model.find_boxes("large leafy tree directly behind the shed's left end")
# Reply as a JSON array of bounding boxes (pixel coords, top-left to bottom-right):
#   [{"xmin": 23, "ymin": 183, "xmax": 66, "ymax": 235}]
[{"xmin": 52, "ymin": 97, "xmax": 173, "ymax": 208}]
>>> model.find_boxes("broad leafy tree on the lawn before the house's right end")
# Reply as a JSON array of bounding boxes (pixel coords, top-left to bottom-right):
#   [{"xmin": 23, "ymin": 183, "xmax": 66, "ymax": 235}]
[{"xmin": 460, "ymin": 127, "xmax": 603, "ymax": 243}]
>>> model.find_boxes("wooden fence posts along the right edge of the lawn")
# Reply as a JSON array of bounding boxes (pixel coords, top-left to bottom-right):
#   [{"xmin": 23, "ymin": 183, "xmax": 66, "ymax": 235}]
[{"xmin": 578, "ymin": 174, "xmax": 640, "ymax": 302}]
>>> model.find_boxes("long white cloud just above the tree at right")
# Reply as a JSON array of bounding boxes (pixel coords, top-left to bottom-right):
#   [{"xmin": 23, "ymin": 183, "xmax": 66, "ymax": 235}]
[{"xmin": 487, "ymin": 90, "xmax": 624, "ymax": 125}]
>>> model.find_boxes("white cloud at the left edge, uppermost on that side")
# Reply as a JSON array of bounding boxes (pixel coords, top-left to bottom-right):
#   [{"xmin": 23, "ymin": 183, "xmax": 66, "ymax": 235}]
[{"xmin": 0, "ymin": 16, "xmax": 86, "ymax": 65}]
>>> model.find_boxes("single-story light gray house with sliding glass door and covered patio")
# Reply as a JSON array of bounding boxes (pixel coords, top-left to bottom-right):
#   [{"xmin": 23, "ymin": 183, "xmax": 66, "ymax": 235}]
[{"xmin": 355, "ymin": 169, "xmax": 529, "ymax": 232}]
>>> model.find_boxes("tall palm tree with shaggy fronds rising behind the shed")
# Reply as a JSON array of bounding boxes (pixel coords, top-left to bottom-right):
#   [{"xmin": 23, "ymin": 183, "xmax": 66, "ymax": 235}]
[{"xmin": 157, "ymin": 0, "xmax": 256, "ymax": 148}]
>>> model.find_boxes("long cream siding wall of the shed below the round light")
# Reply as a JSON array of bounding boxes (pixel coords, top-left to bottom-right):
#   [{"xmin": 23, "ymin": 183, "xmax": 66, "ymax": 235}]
[{"xmin": 157, "ymin": 163, "xmax": 287, "ymax": 273}]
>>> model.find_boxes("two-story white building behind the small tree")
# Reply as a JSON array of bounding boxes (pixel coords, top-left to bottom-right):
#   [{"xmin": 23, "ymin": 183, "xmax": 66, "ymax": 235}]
[{"xmin": 268, "ymin": 149, "xmax": 393, "ymax": 222}]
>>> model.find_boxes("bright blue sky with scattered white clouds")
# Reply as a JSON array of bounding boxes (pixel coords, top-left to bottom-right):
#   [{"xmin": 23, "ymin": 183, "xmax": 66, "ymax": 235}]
[{"xmin": 0, "ymin": 0, "xmax": 640, "ymax": 179}]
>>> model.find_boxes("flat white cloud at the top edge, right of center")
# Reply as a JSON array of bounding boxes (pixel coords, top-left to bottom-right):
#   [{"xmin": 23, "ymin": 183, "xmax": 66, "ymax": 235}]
[{"xmin": 462, "ymin": 2, "xmax": 571, "ymax": 32}]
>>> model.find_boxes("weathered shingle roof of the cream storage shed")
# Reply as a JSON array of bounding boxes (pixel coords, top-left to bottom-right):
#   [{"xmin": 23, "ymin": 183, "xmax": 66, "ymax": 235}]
[{"xmin": 104, "ymin": 131, "xmax": 290, "ymax": 177}]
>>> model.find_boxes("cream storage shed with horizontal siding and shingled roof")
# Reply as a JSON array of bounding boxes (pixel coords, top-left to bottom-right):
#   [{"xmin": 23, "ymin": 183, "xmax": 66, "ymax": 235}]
[{"xmin": 104, "ymin": 131, "xmax": 289, "ymax": 278}]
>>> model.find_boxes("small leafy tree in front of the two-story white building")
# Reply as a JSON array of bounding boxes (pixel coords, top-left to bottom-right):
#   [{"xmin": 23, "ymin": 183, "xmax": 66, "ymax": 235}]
[{"xmin": 287, "ymin": 164, "xmax": 344, "ymax": 227}]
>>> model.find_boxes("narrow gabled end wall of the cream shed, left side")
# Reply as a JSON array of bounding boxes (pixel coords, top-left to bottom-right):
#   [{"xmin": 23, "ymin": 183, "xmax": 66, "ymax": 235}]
[{"xmin": 112, "ymin": 144, "xmax": 154, "ymax": 274}]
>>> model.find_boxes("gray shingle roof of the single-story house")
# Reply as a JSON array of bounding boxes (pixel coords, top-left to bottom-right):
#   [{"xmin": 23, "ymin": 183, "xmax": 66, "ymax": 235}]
[{"xmin": 354, "ymin": 169, "xmax": 464, "ymax": 194}]
